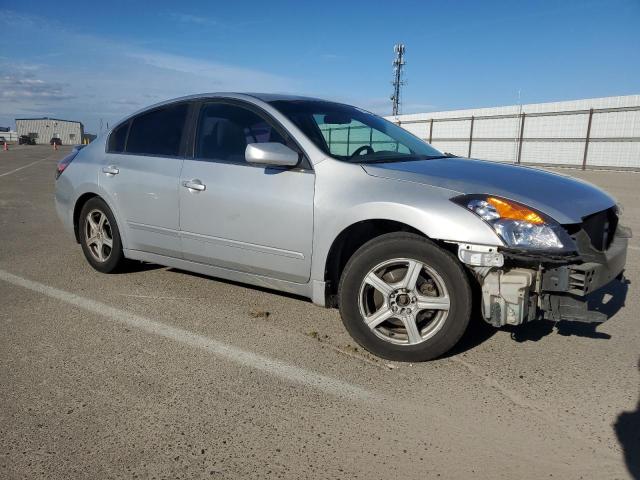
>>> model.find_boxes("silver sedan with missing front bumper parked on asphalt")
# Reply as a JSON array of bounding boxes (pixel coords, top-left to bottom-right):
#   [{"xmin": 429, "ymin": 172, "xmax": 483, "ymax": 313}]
[{"xmin": 56, "ymin": 94, "xmax": 631, "ymax": 361}]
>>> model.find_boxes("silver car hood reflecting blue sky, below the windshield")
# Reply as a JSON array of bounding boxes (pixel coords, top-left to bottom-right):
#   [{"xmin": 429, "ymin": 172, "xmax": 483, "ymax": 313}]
[{"xmin": 362, "ymin": 158, "xmax": 616, "ymax": 224}]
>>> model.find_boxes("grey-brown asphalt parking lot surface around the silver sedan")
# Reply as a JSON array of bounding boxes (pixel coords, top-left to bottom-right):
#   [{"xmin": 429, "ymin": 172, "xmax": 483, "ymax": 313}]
[{"xmin": 0, "ymin": 146, "xmax": 640, "ymax": 479}]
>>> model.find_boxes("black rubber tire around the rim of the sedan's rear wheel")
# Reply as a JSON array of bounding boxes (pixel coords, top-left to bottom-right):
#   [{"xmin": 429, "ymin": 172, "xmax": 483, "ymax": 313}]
[{"xmin": 78, "ymin": 197, "xmax": 126, "ymax": 273}]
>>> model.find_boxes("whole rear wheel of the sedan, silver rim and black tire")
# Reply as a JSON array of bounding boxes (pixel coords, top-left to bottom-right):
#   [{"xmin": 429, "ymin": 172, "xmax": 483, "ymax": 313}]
[{"xmin": 78, "ymin": 197, "xmax": 125, "ymax": 273}]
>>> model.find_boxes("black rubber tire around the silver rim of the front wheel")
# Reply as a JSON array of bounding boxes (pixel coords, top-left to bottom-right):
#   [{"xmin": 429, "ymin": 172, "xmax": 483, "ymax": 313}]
[{"xmin": 339, "ymin": 232, "xmax": 472, "ymax": 362}]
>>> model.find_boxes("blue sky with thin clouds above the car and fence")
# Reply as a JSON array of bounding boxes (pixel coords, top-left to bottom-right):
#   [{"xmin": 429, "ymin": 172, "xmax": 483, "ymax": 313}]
[{"xmin": 0, "ymin": 0, "xmax": 640, "ymax": 132}]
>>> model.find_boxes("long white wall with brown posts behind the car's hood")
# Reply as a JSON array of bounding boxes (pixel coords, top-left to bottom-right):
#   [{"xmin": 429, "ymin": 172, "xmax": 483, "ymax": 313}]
[{"xmin": 387, "ymin": 95, "xmax": 640, "ymax": 169}]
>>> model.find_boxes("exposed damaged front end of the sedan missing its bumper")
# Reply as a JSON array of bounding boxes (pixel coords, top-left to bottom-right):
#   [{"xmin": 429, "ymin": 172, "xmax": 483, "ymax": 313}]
[{"xmin": 458, "ymin": 207, "xmax": 631, "ymax": 327}]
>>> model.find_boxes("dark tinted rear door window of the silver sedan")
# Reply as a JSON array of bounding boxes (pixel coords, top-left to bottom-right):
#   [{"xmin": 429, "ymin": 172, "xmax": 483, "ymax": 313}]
[{"xmin": 127, "ymin": 103, "xmax": 188, "ymax": 156}]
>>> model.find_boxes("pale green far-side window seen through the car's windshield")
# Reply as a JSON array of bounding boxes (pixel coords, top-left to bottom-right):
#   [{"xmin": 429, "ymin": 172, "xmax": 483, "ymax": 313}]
[{"xmin": 313, "ymin": 114, "xmax": 411, "ymax": 157}]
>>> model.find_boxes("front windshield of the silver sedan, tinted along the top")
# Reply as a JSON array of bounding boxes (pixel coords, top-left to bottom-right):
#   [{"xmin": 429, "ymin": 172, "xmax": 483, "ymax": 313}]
[{"xmin": 269, "ymin": 100, "xmax": 445, "ymax": 163}]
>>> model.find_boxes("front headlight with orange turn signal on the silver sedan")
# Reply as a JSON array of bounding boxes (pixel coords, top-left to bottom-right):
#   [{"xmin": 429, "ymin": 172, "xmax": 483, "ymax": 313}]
[{"xmin": 452, "ymin": 195, "xmax": 571, "ymax": 250}]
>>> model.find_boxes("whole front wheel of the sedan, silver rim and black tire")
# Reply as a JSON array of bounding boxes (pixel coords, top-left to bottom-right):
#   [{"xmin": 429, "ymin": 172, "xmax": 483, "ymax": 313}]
[{"xmin": 339, "ymin": 233, "xmax": 472, "ymax": 362}]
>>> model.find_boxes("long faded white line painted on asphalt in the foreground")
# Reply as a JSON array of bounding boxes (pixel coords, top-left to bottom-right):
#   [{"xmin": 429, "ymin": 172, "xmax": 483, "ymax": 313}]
[{"xmin": 0, "ymin": 270, "xmax": 378, "ymax": 400}]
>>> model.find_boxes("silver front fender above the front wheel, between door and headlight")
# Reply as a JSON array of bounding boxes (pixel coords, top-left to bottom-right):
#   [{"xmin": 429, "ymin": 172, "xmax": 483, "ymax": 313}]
[{"xmin": 311, "ymin": 159, "xmax": 503, "ymax": 280}]
